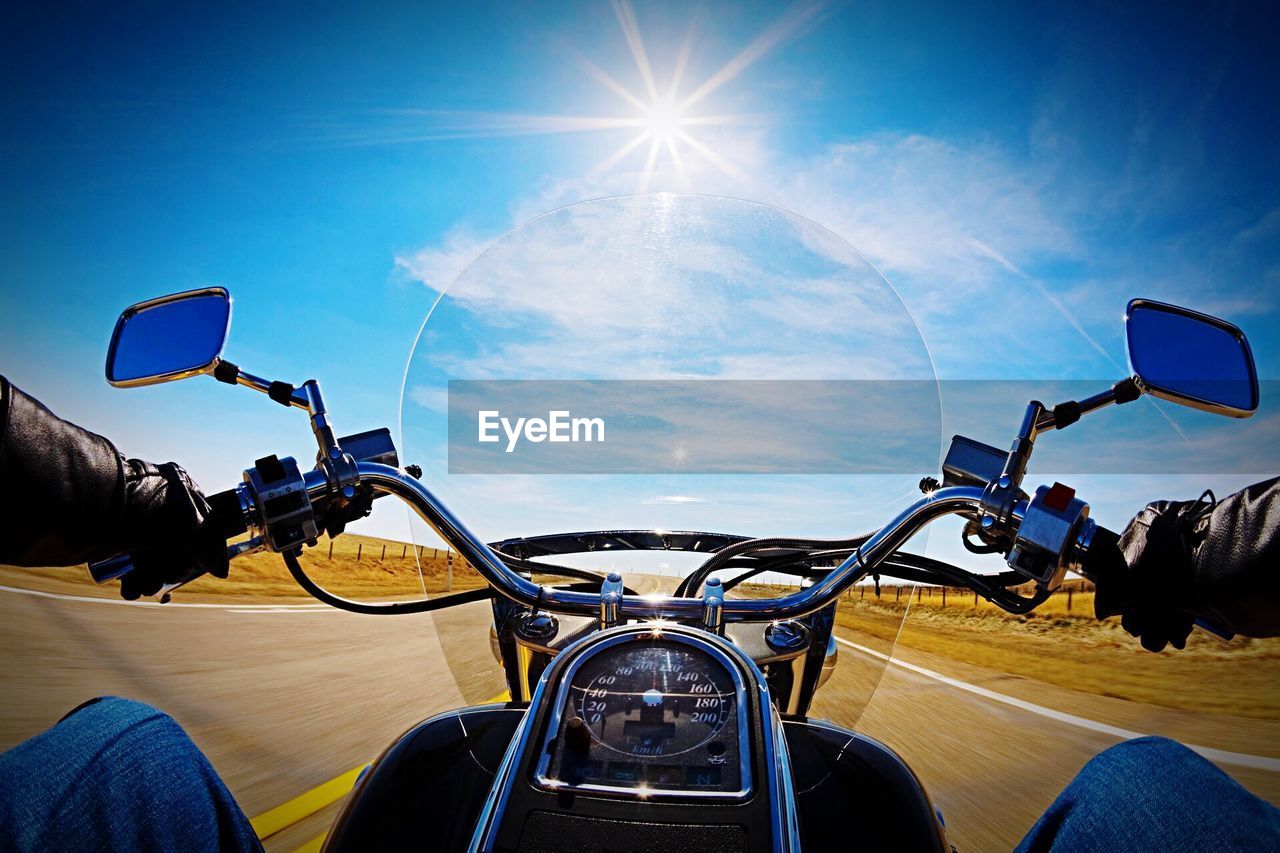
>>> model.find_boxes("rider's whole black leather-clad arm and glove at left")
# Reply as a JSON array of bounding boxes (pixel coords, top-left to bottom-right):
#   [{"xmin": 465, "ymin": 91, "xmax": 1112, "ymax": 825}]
[{"xmin": 0, "ymin": 377, "xmax": 227, "ymax": 599}]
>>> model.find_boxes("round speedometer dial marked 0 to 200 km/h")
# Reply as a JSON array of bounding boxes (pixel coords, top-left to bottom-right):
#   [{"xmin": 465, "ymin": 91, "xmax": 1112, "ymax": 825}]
[{"xmin": 571, "ymin": 647, "xmax": 735, "ymax": 756}]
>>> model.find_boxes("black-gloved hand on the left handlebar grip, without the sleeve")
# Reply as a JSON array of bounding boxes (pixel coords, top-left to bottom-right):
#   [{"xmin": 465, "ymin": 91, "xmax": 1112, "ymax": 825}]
[{"xmin": 120, "ymin": 459, "xmax": 228, "ymax": 601}]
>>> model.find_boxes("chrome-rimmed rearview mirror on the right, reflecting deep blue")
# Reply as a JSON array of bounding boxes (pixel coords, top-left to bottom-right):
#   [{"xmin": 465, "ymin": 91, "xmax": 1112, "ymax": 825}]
[{"xmin": 1125, "ymin": 300, "xmax": 1258, "ymax": 418}]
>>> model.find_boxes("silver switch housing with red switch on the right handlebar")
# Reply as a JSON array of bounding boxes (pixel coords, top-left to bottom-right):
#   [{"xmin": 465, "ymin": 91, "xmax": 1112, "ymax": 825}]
[{"xmin": 1009, "ymin": 483, "xmax": 1089, "ymax": 590}]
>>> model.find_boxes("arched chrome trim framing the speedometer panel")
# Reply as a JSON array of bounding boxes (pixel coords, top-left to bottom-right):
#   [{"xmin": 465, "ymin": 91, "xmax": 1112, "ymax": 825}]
[{"xmin": 534, "ymin": 622, "xmax": 747, "ymax": 802}]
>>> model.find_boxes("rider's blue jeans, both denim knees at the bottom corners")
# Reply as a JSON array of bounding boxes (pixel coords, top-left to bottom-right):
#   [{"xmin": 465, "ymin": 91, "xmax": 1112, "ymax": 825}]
[{"xmin": 0, "ymin": 697, "xmax": 1280, "ymax": 852}]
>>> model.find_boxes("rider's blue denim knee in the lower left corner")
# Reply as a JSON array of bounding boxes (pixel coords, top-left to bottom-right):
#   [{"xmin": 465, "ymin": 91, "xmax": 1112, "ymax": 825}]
[{"xmin": 0, "ymin": 697, "xmax": 262, "ymax": 850}]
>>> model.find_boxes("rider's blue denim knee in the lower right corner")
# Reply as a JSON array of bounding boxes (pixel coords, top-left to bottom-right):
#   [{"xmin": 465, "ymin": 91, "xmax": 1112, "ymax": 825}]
[{"xmin": 1018, "ymin": 738, "xmax": 1280, "ymax": 852}]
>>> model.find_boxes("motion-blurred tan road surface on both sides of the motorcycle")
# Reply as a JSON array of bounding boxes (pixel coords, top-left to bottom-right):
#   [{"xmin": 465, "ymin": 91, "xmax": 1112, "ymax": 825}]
[{"xmin": 0, "ymin": 590, "xmax": 1280, "ymax": 850}]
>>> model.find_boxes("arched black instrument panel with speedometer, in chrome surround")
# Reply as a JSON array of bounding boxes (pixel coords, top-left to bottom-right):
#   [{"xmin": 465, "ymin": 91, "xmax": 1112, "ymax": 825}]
[{"xmin": 535, "ymin": 633, "xmax": 751, "ymax": 799}]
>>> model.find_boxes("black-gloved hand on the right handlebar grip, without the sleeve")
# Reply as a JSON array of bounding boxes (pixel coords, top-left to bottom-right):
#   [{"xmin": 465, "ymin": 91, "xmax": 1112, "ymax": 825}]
[{"xmin": 1091, "ymin": 492, "xmax": 1213, "ymax": 652}]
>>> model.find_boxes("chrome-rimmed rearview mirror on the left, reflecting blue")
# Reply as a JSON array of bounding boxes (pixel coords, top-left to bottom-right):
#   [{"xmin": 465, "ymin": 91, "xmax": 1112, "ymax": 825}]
[{"xmin": 106, "ymin": 287, "xmax": 232, "ymax": 388}]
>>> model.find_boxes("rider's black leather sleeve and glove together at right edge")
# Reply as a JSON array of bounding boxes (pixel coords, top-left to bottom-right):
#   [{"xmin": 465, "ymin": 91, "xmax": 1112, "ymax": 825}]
[{"xmin": 1091, "ymin": 478, "xmax": 1280, "ymax": 652}]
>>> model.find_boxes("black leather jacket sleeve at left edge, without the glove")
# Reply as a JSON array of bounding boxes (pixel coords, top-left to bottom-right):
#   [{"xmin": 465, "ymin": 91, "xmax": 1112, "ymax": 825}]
[{"xmin": 0, "ymin": 377, "xmax": 128, "ymax": 566}]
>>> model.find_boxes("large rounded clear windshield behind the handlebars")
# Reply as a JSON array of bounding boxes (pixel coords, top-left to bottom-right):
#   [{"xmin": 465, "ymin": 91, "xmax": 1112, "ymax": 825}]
[{"xmin": 401, "ymin": 195, "xmax": 941, "ymax": 722}]
